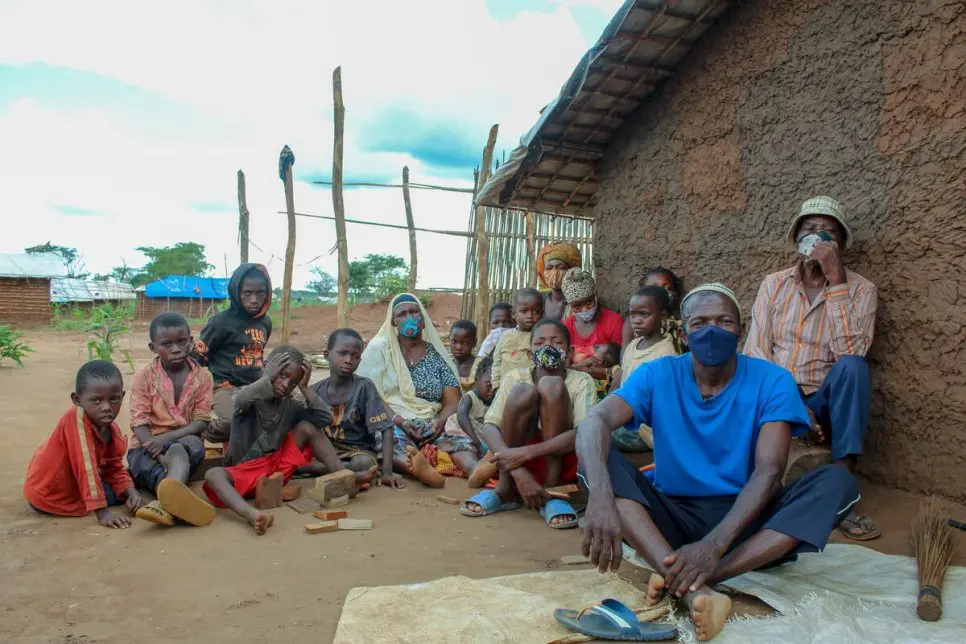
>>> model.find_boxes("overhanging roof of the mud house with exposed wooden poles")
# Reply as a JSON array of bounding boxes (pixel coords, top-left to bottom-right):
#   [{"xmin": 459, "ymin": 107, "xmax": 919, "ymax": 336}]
[{"xmin": 476, "ymin": 0, "xmax": 728, "ymax": 216}]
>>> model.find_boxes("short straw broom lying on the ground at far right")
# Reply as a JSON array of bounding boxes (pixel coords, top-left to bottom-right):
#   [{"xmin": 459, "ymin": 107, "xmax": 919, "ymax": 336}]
[{"xmin": 911, "ymin": 498, "xmax": 954, "ymax": 622}]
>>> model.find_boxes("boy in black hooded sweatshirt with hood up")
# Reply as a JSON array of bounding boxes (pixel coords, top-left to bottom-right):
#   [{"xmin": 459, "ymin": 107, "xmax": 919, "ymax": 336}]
[{"xmin": 192, "ymin": 264, "xmax": 272, "ymax": 443}]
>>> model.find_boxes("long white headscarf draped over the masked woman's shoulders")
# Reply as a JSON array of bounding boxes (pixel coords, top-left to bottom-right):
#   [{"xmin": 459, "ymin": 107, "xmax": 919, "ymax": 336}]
[{"xmin": 358, "ymin": 293, "xmax": 459, "ymax": 420}]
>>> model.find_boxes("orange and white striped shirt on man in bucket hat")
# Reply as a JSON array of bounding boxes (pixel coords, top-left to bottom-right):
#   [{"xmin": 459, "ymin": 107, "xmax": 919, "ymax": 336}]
[{"xmin": 744, "ymin": 266, "xmax": 878, "ymax": 395}]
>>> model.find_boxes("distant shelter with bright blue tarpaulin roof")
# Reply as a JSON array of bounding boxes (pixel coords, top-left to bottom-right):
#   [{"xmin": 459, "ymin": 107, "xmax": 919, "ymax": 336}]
[{"xmin": 137, "ymin": 275, "xmax": 228, "ymax": 320}]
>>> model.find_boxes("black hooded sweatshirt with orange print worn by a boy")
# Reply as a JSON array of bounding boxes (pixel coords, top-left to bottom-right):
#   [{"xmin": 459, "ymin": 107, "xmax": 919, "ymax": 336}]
[{"xmin": 192, "ymin": 264, "xmax": 272, "ymax": 387}]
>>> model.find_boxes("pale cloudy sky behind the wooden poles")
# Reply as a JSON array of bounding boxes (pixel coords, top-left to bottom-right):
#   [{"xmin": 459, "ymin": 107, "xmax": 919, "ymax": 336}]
[{"xmin": 0, "ymin": 0, "xmax": 621, "ymax": 288}]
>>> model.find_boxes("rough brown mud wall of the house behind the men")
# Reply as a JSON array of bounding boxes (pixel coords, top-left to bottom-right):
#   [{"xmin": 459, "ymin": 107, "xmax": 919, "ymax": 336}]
[{"xmin": 594, "ymin": 0, "xmax": 966, "ymax": 500}]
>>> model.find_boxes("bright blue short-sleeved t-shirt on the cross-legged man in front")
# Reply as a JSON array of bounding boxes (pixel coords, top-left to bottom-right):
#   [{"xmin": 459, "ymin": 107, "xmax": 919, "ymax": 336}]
[{"xmin": 616, "ymin": 354, "xmax": 810, "ymax": 496}]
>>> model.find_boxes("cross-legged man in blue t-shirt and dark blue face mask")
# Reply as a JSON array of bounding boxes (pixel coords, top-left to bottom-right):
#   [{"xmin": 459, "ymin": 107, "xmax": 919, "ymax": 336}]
[{"xmin": 577, "ymin": 284, "xmax": 859, "ymax": 640}]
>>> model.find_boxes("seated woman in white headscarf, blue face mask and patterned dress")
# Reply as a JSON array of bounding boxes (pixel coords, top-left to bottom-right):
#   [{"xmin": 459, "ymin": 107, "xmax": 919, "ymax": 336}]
[{"xmin": 357, "ymin": 293, "xmax": 479, "ymax": 487}]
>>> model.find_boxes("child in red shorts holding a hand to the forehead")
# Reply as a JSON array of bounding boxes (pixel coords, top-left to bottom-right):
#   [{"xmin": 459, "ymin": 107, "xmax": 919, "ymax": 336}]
[{"xmin": 204, "ymin": 345, "xmax": 376, "ymax": 535}]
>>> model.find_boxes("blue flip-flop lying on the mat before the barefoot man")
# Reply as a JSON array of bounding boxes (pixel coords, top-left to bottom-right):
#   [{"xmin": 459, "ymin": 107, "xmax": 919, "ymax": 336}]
[{"xmin": 553, "ymin": 599, "xmax": 678, "ymax": 642}]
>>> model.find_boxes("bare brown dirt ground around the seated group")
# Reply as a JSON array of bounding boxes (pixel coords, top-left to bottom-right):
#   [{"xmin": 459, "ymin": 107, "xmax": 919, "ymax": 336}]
[{"xmin": 0, "ymin": 303, "xmax": 966, "ymax": 643}]
